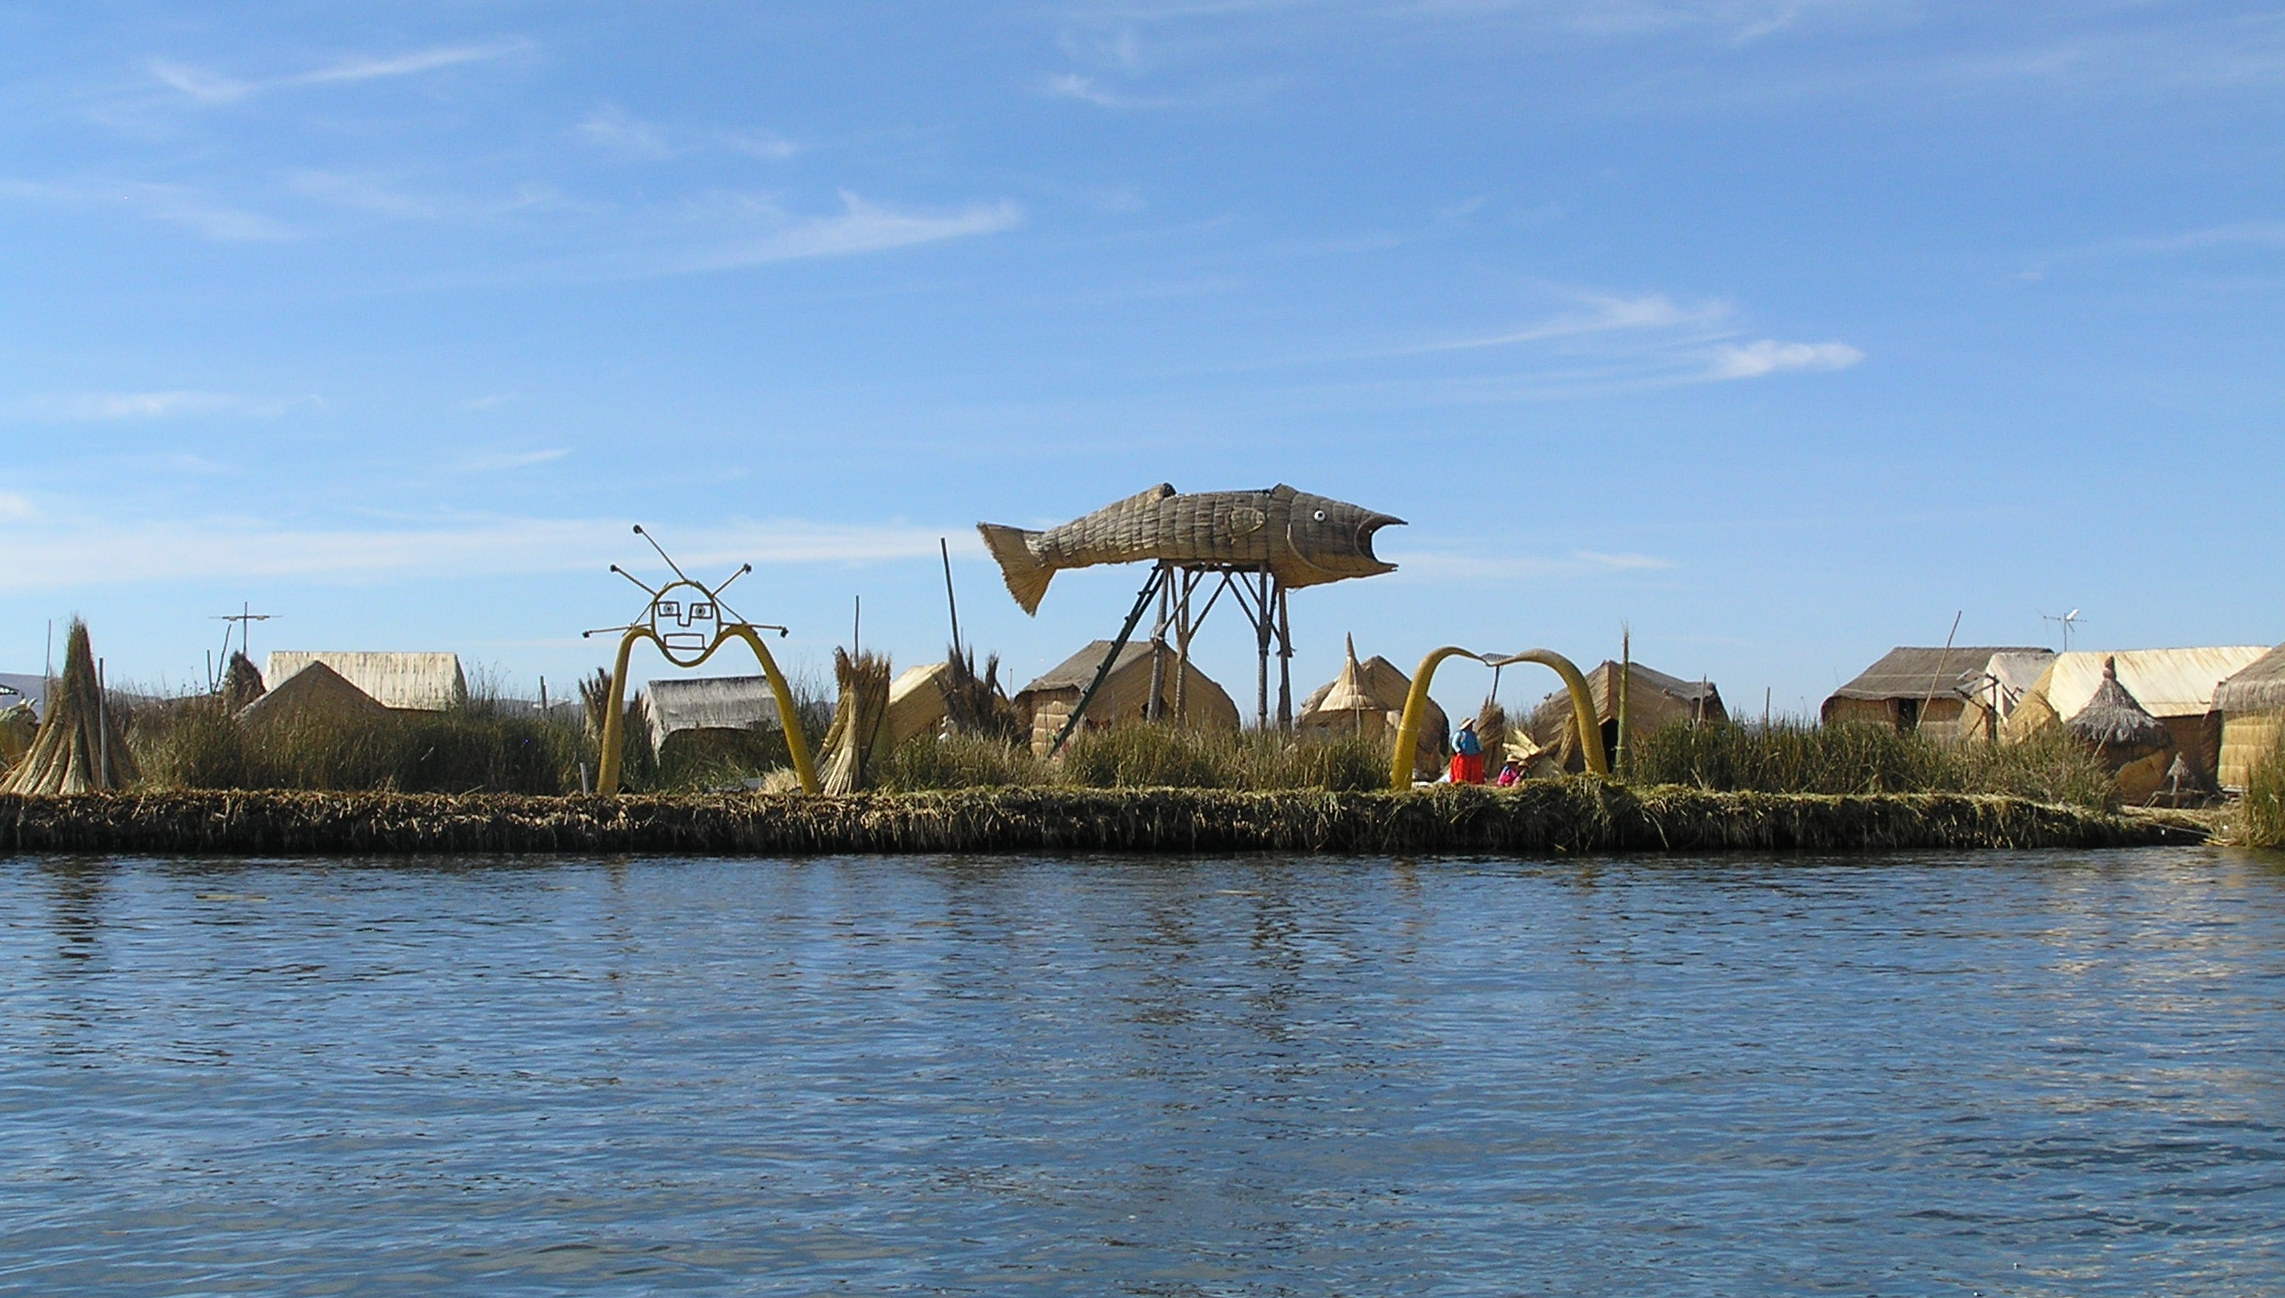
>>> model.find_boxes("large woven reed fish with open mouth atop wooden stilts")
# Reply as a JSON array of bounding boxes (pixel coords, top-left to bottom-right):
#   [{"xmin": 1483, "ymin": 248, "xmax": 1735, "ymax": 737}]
[{"xmin": 976, "ymin": 482, "xmax": 1403, "ymax": 612}]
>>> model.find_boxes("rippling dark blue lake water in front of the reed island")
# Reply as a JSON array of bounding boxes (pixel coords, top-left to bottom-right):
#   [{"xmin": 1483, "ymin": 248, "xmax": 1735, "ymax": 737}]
[{"xmin": 0, "ymin": 850, "xmax": 2285, "ymax": 1296}]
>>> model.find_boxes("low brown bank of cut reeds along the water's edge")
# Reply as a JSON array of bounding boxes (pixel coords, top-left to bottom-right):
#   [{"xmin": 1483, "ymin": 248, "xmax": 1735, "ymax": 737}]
[{"xmin": 0, "ymin": 779, "xmax": 2207, "ymax": 857}]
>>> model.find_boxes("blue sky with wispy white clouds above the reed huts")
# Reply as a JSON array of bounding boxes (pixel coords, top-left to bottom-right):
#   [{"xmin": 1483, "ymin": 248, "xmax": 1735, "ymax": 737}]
[{"xmin": 0, "ymin": 0, "xmax": 2285, "ymax": 711}]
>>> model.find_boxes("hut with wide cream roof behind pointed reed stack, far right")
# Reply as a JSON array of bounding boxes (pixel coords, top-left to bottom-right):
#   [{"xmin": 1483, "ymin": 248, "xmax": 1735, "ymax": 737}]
[{"xmin": 1999, "ymin": 644, "xmax": 2269, "ymax": 784}]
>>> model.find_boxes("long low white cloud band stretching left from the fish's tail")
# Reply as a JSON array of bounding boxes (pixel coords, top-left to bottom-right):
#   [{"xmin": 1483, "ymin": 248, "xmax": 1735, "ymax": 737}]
[{"xmin": 0, "ymin": 516, "xmax": 980, "ymax": 592}]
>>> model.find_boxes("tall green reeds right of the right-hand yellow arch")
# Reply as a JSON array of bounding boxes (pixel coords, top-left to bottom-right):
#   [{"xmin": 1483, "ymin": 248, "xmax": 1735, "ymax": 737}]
[{"xmin": 1631, "ymin": 720, "xmax": 2116, "ymax": 809}]
